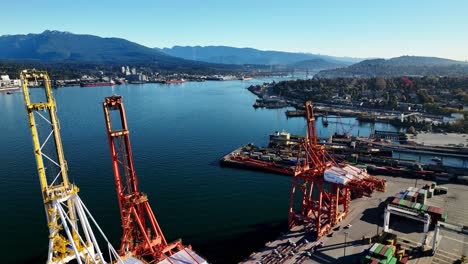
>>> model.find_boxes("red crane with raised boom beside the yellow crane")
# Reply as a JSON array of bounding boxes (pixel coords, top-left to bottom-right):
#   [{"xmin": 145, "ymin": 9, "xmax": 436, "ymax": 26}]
[{"xmin": 103, "ymin": 95, "xmax": 206, "ymax": 263}]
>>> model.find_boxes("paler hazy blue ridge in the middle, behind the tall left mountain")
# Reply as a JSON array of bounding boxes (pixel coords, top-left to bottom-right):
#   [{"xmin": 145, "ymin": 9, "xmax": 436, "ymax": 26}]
[{"xmin": 156, "ymin": 46, "xmax": 361, "ymax": 66}]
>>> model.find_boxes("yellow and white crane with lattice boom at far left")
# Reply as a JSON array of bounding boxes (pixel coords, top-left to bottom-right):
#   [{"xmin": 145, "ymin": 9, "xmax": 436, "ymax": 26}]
[{"xmin": 20, "ymin": 70, "xmax": 122, "ymax": 264}]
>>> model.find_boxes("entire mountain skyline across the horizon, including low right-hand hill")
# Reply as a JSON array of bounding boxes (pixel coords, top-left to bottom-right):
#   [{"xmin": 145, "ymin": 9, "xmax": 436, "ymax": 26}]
[{"xmin": 0, "ymin": 30, "xmax": 468, "ymax": 78}]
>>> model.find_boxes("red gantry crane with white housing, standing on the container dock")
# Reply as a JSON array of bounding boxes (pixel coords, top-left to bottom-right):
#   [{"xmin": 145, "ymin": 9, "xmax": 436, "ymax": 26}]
[{"xmin": 288, "ymin": 101, "xmax": 386, "ymax": 238}]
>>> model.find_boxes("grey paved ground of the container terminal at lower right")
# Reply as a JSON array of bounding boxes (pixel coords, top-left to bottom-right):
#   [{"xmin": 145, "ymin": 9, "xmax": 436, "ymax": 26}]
[{"xmin": 241, "ymin": 176, "xmax": 468, "ymax": 264}]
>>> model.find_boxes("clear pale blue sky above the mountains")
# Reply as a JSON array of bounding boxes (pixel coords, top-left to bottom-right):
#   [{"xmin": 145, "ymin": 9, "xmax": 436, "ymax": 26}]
[{"xmin": 0, "ymin": 0, "xmax": 468, "ymax": 60}]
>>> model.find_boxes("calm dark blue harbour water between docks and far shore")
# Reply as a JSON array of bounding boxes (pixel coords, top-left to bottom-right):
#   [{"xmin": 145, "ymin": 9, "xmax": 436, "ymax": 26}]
[{"xmin": 0, "ymin": 80, "xmax": 394, "ymax": 263}]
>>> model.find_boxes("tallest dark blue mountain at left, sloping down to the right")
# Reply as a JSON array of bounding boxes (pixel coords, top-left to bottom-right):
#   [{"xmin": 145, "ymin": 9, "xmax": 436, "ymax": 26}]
[{"xmin": 0, "ymin": 30, "xmax": 236, "ymax": 69}]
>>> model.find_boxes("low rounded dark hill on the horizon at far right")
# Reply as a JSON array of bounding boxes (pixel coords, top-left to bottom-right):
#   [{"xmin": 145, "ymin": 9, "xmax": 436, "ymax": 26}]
[{"xmin": 316, "ymin": 56, "xmax": 468, "ymax": 78}]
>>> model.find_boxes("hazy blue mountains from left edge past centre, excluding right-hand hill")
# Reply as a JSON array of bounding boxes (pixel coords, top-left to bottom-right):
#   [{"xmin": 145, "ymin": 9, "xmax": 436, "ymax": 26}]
[{"xmin": 0, "ymin": 30, "xmax": 352, "ymax": 70}]
